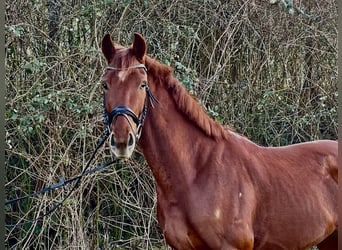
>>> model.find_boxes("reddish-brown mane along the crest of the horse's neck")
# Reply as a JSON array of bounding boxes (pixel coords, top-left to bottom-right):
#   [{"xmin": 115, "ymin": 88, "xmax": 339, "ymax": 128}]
[{"xmin": 145, "ymin": 56, "xmax": 232, "ymax": 139}]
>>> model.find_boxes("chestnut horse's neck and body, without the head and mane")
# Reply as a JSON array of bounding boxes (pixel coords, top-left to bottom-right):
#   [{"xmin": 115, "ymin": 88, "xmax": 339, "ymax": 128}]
[{"xmin": 140, "ymin": 79, "xmax": 337, "ymax": 249}]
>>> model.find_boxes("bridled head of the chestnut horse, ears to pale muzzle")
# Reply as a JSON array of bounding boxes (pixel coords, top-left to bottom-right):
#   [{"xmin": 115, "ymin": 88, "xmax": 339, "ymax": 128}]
[{"xmin": 101, "ymin": 33, "xmax": 153, "ymax": 158}]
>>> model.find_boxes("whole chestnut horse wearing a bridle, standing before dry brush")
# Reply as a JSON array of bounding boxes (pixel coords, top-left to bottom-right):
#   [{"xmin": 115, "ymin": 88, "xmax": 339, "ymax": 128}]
[{"xmin": 101, "ymin": 33, "xmax": 338, "ymax": 250}]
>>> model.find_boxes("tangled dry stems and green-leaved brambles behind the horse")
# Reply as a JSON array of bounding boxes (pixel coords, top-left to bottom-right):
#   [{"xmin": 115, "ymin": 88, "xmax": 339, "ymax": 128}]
[{"xmin": 5, "ymin": 0, "xmax": 337, "ymax": 249}]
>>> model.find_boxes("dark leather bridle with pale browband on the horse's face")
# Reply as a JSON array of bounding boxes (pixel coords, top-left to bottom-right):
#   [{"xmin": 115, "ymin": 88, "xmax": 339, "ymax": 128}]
[{"xmin": 103, "ymin": 64, "xmax": 158, "ymax": 140}]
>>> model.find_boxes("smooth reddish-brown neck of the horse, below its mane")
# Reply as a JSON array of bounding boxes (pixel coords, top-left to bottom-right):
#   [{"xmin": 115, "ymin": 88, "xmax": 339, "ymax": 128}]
[{"xmin": 139, "ymin": 77, "xmax": 226, "ymax": 194}]
